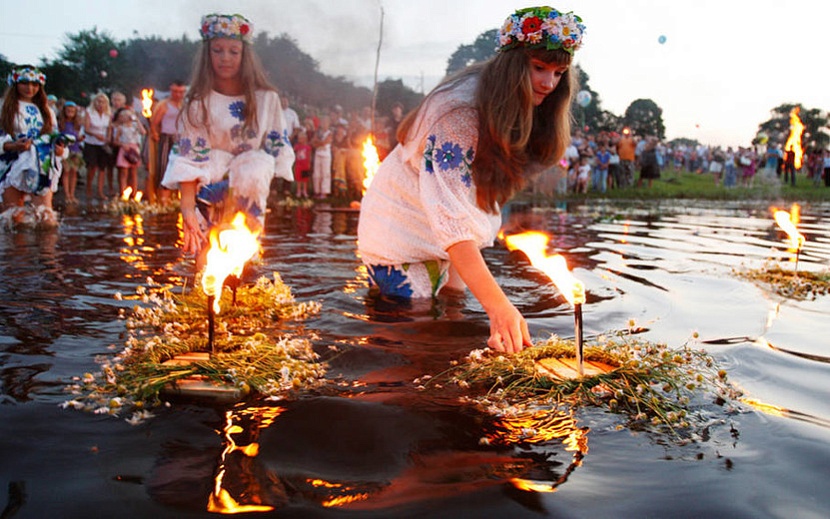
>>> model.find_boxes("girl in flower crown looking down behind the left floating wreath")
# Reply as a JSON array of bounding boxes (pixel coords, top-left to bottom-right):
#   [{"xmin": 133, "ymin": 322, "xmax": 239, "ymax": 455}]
[{"xmin": 162, "ymin": 14, "xmax": 294, "ymax": 267}]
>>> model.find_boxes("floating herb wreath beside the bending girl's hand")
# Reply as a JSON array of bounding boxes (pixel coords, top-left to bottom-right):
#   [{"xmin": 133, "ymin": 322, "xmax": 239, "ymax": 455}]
[{"xmin": 438, "ymin": 333, "xmax": 741, "ymax": 442}]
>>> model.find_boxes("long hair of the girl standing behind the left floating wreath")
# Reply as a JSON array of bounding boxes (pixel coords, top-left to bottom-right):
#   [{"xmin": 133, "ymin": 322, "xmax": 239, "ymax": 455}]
[{"xmin": 184, "ymin": 40, "xmax": 277, "ymax": 133}]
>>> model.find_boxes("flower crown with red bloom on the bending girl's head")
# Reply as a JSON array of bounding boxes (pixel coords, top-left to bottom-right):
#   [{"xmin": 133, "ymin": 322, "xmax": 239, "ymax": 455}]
[{"xmin": 496, "ymin": 6, "xmax": 585, "ymax": 54}]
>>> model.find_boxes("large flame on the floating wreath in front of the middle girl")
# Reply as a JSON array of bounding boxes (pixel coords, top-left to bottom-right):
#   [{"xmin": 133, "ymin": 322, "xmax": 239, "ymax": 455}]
[{"xmin": 202, "ymin": 212, "xmax": 259, "ymax": 313}]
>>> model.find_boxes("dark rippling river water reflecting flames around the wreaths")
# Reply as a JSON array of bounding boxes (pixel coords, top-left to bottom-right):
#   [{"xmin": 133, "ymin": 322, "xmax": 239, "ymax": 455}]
[{"xmin": 0, "ymin": 198, "xmax": 830, "ymax": 518}]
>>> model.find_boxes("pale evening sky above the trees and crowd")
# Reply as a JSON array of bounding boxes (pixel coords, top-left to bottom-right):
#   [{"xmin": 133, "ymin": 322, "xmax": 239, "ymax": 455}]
[{"xmin": 0, "ymin": 0, "xmax": 830, "ymax": 146}]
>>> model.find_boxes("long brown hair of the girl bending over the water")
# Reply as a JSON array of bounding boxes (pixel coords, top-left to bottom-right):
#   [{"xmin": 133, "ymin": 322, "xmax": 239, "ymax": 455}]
[{"xmin": 398, "ymin": 48, "xmax": 576, "ymax": 212}]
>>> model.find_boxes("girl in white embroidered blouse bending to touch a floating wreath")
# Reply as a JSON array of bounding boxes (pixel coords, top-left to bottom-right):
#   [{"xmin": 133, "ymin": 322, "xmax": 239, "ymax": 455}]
[{"xmin": 358, "ymin": 7, "xmax": 585, "ymax": 352}]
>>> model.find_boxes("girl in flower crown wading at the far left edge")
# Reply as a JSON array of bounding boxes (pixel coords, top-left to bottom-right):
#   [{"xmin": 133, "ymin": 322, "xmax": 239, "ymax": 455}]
[{"xmin": 0, "ymin": 65, "xmax": 69, "ymax": 227}]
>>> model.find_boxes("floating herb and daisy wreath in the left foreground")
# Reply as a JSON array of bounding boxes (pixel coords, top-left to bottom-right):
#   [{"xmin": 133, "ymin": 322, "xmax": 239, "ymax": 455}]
[{"xmin": 61, "ymin": 273, "xmax": 325, "ymax": 423}]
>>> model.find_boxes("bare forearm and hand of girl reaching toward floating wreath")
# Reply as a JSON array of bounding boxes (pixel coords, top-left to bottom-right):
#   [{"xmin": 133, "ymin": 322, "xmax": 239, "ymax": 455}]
[{"xmin": 447, "ymin": 241, "xmax": 533, "ymax": 353}]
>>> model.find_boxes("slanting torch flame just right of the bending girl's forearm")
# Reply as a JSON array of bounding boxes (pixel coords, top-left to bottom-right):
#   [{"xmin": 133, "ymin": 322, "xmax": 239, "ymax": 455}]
[{"xmin": 502, "ymin": 231, "xmax": 585, "ymax": 306}]
